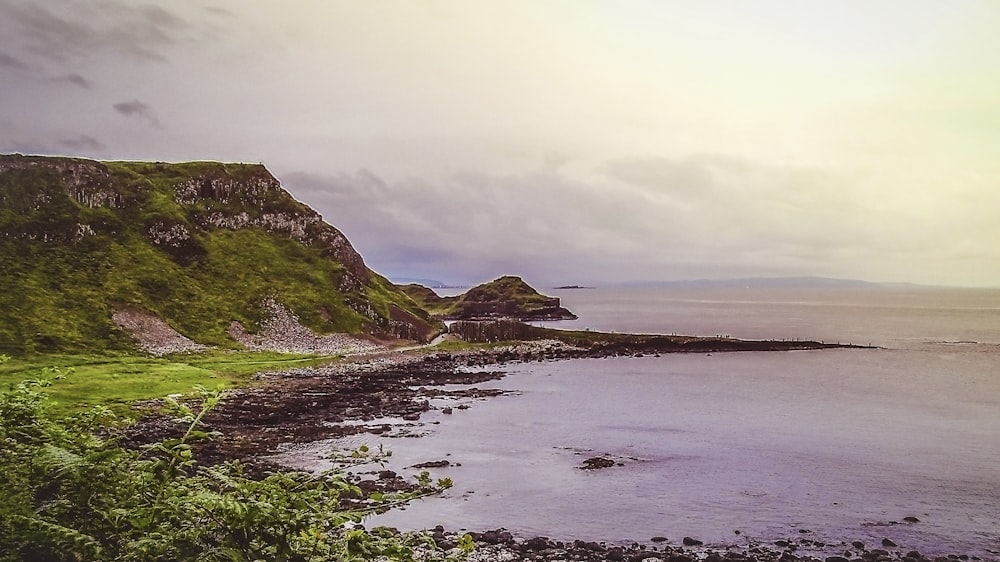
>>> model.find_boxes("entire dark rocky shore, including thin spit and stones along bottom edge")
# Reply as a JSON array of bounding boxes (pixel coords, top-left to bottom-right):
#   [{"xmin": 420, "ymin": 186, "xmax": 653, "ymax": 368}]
[{"xmin": 125, "ymin": 338, "xmax": 984, "ymax": 562}]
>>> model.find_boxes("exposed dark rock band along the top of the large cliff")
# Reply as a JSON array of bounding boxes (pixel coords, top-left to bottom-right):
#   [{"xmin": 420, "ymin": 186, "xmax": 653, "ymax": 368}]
[{"xmin": 0, "ymin": 155, "xmax": 370, "ymax": 284}]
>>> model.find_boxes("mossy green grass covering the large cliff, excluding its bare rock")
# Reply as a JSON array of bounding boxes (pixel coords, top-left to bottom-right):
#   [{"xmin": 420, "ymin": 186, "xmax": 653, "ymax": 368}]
[{"xmin": 0, "ymin": 157, "xmax": 438, "ymax": 354}]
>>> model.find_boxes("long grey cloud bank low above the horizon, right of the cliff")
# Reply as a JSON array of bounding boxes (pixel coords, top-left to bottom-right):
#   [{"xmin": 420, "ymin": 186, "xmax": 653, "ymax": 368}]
[{"xmin": 283, "ymin": 155, "xmax": 968, "ymax": 284}]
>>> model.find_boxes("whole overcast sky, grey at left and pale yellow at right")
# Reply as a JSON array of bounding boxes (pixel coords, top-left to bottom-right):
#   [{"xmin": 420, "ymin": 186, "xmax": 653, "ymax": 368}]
[{"xmin": 0, "ymin": 0, "xmax": 1000, "ymax": 286}]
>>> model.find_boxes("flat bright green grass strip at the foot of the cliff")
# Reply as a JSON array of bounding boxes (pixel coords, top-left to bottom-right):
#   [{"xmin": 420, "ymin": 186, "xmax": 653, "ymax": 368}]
[{"xmin": 0, "ymin": 351, "xmax": 338, "ymax": 416}]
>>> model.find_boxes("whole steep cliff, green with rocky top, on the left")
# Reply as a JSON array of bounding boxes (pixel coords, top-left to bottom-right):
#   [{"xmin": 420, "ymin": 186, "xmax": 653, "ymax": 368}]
[{"xmin": 0, "ymin": 155, "xmax": 439, "ymax": 351}]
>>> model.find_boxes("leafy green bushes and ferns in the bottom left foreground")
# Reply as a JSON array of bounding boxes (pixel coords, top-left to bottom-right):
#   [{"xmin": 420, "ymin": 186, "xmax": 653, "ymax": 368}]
[{"xmin": 0, "ymin": 356, "xmax": 469, "ymax": 562}]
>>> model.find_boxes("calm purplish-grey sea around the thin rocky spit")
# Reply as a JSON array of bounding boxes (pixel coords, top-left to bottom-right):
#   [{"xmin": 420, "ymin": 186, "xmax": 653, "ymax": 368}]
[{"xmin": 272, "ymin": 287, "xmax": 1000, "ymax": 560}]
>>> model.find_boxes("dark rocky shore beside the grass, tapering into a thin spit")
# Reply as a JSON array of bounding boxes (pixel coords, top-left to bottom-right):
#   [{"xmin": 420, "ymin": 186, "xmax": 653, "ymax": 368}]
[{"xmin": 174, "ymin": 330, "xmax": 860, "ymax": 462}]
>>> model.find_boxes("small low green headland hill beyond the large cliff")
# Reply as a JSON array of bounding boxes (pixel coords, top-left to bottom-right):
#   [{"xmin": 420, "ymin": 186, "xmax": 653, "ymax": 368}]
[{"xmin": 401, "ymin": 276, "xmax": 576, "ymax": 320}]
